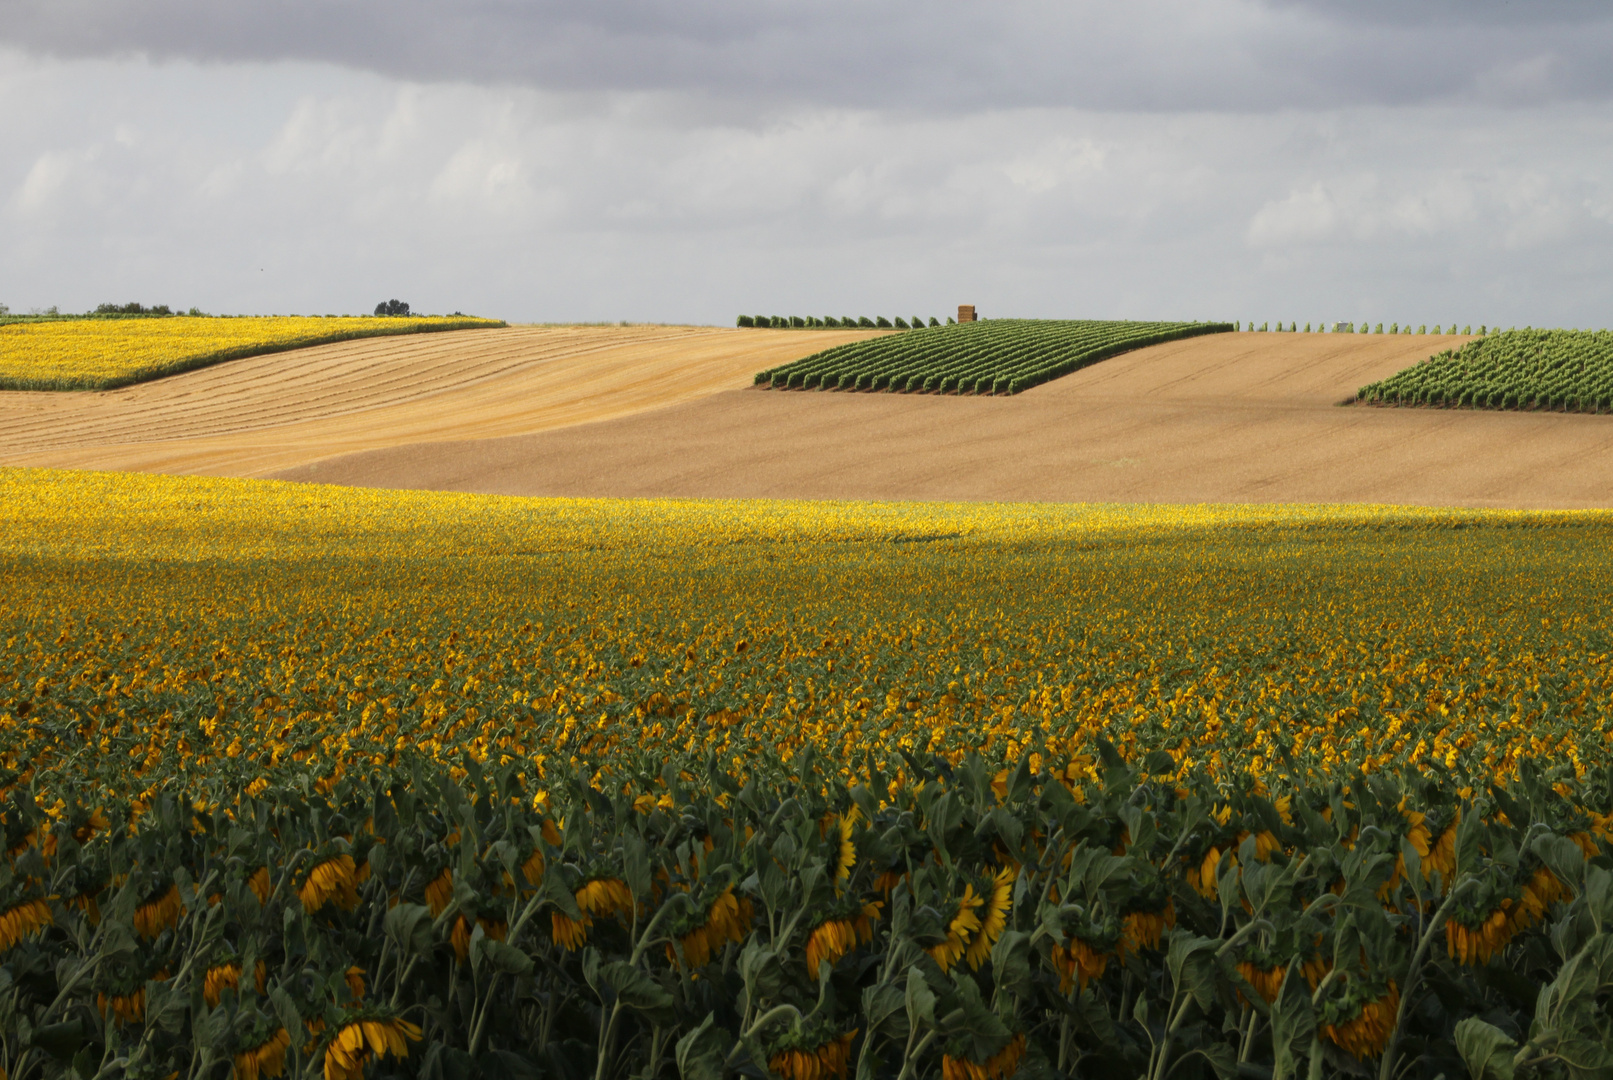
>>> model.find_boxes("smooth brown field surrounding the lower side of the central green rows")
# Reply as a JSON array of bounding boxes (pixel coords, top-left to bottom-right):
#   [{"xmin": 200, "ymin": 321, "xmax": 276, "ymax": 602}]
[{"xmin": 279, "ymin": 334, "xmax": 1613, "ymax": 508}]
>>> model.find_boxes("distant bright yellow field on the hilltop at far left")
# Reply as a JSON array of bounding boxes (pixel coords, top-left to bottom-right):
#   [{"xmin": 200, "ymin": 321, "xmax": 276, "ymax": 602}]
[{"xmin": 0, "ymin": 316, "xmax": 503, "ymax": 390}]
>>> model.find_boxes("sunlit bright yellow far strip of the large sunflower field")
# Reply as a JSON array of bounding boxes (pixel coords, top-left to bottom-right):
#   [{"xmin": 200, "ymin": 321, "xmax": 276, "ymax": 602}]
[{"xmin": 0, "ymin": 467, "xmax": 1613, "ymax": 559}]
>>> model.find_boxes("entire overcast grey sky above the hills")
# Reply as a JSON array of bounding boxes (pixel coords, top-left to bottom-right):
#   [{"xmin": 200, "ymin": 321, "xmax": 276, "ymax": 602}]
[{"xmin": 0, "ymin": 0, "xmax": 1613, "ymax": 327}]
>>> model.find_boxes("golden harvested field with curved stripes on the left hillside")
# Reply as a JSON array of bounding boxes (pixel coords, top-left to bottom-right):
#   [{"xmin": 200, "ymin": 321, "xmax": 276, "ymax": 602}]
[{"xmin": 0, "ymin": 326, "xmax": 876, "ymax": 476}]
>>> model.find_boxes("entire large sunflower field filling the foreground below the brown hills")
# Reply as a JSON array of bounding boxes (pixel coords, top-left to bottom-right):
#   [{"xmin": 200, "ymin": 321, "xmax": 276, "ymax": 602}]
[{"xmin": 0, "ymin": 469, "xmax": 1613, "ymax": 1080}]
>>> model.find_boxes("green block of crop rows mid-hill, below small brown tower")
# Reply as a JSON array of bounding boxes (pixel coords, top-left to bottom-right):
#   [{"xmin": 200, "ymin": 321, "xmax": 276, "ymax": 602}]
[{"xmin": 756, "ymin": 319, "xmax": 1232, "ymax": 393}]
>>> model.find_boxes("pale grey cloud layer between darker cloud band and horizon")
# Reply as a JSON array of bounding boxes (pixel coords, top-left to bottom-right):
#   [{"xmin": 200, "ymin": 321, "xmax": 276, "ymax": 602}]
[{"xmin": 0, "ymin": 50, "xmax": 1613, "ymax": 326}]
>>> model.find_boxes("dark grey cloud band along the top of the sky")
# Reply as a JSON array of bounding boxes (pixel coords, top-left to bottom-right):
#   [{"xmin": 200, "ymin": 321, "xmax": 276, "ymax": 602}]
[{"xmin": 9, "ymin": 0, "xmax": 1613, "ymax": 111}]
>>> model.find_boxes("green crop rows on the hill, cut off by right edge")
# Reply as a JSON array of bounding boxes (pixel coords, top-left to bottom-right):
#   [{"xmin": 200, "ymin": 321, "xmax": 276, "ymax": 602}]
[{"xmin": 1357, "ymin": 330, "xmax": 1613, "ymax": 413}]
